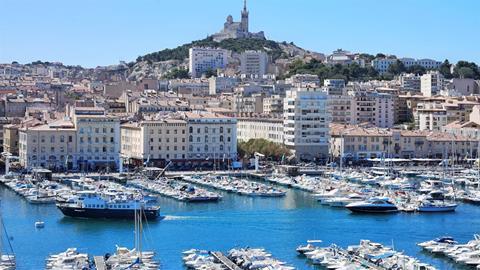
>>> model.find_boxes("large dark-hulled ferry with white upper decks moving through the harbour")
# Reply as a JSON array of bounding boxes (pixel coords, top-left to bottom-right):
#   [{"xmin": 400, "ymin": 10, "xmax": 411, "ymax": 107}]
[{"xmin": 56, "ymin": 191, "xmax": 160, "ymax": 219}]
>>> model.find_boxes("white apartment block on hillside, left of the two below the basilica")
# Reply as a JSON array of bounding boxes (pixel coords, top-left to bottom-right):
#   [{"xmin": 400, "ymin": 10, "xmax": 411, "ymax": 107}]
[{"xmin": 188, "ymin": 47, "xmax": 228, "ymax": 78}]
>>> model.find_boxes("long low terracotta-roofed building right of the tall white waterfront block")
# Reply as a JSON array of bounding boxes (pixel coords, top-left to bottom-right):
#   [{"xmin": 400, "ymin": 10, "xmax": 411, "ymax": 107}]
[{"xmin": 330, "ymin": 124, "xmax": 478, "ymax": 160}]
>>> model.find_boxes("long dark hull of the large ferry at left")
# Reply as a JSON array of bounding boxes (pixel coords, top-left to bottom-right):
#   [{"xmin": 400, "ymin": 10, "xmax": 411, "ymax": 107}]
[{"xmin": 57, "ymin": 205, "xmax": 160, "ymax": 220}]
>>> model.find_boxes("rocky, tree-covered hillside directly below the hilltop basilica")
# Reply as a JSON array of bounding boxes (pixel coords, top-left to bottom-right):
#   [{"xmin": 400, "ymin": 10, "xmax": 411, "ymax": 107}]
[{"xmin": 129, "ymin": 37, "xmax": 316, "ymax": 80}]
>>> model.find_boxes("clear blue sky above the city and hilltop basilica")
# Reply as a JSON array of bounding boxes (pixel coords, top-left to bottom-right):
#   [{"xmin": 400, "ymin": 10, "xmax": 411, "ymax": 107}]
[{"xmin": 0, "ymin": 0, "xmax": 480, "ymax": 67}]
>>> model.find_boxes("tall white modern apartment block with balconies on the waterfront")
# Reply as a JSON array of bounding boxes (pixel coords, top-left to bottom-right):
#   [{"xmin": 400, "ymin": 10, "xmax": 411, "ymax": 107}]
[{"xmin": 283, "ymin": 88, "xmax": 331, "ymax": 160}]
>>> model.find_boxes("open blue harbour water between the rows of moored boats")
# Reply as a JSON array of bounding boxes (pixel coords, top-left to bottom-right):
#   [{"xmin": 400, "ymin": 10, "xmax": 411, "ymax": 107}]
[{"xmin": 0, "ymin": 184, "xmax": 480, "ymax": 269}]
